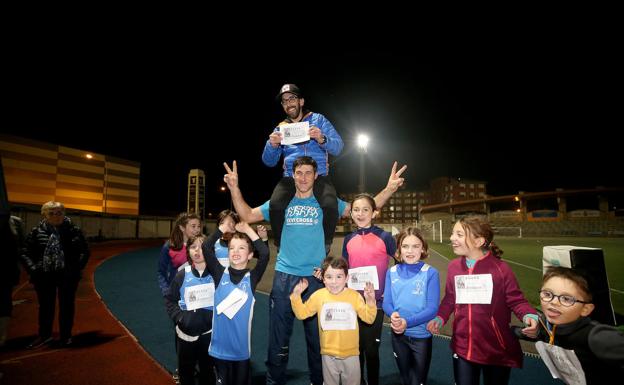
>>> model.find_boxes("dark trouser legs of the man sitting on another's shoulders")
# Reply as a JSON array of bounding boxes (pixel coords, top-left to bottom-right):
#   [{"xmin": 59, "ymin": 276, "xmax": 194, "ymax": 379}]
[{"xmin": 269, "ymin": 175, "xmax": 338, "ymax": 251}]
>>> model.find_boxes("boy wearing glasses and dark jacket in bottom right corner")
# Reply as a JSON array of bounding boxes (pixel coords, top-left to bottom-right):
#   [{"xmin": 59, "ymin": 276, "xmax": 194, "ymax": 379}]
[{"xmin": 536, "ymin": 267, "xmax": 624, "ymax": 385}]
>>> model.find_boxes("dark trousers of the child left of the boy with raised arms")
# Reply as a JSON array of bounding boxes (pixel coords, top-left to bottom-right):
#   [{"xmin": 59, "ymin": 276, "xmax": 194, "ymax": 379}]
[{"xmin": 176, "ymin": 333, "xmax": 216, "ymax": 385}]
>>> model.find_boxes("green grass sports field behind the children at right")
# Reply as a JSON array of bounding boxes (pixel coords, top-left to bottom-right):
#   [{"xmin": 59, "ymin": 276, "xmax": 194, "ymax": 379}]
[{"xmin": 429, "ymin": 237, "xmax": 624, "ymax": 314}]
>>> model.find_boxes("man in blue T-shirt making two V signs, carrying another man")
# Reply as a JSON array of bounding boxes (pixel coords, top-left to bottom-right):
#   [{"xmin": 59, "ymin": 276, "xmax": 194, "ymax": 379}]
[{"xmin": 223, "ymin": 156, "xmax": 407, "ymax": 385}]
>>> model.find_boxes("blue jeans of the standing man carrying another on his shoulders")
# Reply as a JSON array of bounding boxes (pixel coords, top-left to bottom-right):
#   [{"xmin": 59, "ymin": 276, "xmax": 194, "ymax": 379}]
[{"xmin": 266, "ymin": 271, "xmax": 323, "ymax": 385}]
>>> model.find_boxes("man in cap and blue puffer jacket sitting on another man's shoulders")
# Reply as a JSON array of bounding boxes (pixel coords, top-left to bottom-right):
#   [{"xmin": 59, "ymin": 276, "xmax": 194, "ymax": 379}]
[{"xmin": 262, "ymin": 84, "xmax": 344, "ymax": 253}]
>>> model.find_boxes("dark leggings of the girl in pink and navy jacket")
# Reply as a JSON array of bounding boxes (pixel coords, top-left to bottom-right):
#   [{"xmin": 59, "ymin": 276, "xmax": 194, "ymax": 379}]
[{"xmin": 358, "ymin": 309, "xmax": 384, "ymax": 385}]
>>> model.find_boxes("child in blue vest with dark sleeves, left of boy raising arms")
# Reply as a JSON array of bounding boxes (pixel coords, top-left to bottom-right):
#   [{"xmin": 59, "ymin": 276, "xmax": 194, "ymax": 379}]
[{"xmin": 165, "ymin": 235, "xmax": 215, "ymax": 385}]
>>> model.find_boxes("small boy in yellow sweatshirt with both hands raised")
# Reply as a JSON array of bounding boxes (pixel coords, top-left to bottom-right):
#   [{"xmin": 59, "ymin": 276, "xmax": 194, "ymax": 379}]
[{"xmin": 290, "ymin": 257, "xmax": 377, "ymax": 385}]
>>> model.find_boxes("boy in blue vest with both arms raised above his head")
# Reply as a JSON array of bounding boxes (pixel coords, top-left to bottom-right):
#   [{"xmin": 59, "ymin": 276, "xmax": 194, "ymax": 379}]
[{"xmin": 203, "ymin": 222, "xmax": 269, "ymax": 385}]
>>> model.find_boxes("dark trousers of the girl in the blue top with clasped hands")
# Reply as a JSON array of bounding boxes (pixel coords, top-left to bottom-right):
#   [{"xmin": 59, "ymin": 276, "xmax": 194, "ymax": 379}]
[{"xmin": 392, "ymin": 333, "xmax": 433, "ymax": 385}]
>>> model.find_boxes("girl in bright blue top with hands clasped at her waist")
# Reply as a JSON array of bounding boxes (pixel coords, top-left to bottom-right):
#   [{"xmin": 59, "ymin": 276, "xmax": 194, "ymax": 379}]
[{"xmin": 383, "ymin": 227, "xmax": 440, "ymax": 385}]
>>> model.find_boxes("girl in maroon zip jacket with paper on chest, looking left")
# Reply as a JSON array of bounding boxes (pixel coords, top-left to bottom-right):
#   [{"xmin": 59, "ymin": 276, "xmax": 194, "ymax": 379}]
[{"xmin": 427, "ymin": 216, "xmax": 538, "ymax": 385}]
